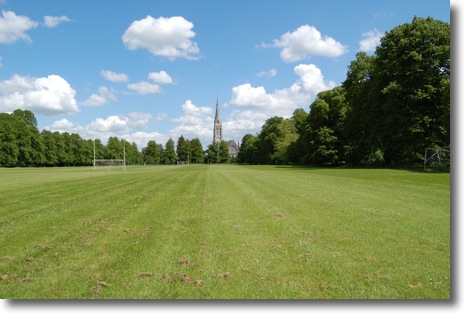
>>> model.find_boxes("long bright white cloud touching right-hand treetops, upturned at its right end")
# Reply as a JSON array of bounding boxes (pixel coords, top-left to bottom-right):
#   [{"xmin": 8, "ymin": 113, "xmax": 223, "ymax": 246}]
[{"xmin": 230, "ymin": 64, "xmax": 335, "ymax": 116}]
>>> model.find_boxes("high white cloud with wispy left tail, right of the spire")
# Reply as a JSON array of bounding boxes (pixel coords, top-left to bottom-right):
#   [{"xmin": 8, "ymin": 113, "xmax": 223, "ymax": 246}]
[{"xmin": 261, "ymin": 25, "xmax": 348, "ymax": 62}]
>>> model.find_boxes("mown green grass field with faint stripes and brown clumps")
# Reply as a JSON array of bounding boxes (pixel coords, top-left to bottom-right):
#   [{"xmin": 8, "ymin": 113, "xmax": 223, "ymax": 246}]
[{"xmin": 0, "ymin": 165, "xmax": 450, "ymax": 299}]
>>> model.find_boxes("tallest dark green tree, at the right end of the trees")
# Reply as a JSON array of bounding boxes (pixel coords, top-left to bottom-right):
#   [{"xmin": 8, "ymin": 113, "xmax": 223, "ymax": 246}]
[{"xmin": 371, "ymin": 17, "xmax": 451, "ymax": 164}]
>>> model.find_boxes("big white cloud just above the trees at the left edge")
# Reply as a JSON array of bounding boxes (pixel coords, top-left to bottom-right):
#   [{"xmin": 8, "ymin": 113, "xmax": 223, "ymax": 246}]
[{"xmin": 0, "ymin": 75, "xmax": 79, "ymax": 116}]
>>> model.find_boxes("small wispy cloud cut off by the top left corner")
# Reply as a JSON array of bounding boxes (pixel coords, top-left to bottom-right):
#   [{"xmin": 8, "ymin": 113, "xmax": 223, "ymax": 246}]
[{"xmin": 0, "ymin": 11, "xmax": 39, "ymax": 44}]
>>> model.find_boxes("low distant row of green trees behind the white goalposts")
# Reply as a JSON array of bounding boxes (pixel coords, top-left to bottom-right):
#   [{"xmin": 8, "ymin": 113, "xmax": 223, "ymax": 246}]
[{"xmin": 0, "ymin": 109, "xmax": 234, "ymax": 167}]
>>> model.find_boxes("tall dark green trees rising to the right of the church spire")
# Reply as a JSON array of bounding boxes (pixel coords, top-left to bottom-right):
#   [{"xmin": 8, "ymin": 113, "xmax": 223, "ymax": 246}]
[{"xmin": 237, "ymin": 17, "xmax": 451, "ymax": 166}]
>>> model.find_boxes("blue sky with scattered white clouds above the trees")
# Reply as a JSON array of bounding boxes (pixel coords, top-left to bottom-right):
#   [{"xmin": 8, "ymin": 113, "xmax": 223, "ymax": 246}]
[{"xmin": 0, "ymin": 0, "xmax": 450, "ymax": 150}]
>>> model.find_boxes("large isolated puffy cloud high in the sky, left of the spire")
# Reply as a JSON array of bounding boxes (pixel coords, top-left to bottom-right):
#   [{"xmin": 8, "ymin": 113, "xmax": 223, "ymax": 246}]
[{"xmin": 122, "ymin": 15, "xmax": 200, "ymax": 60}]
